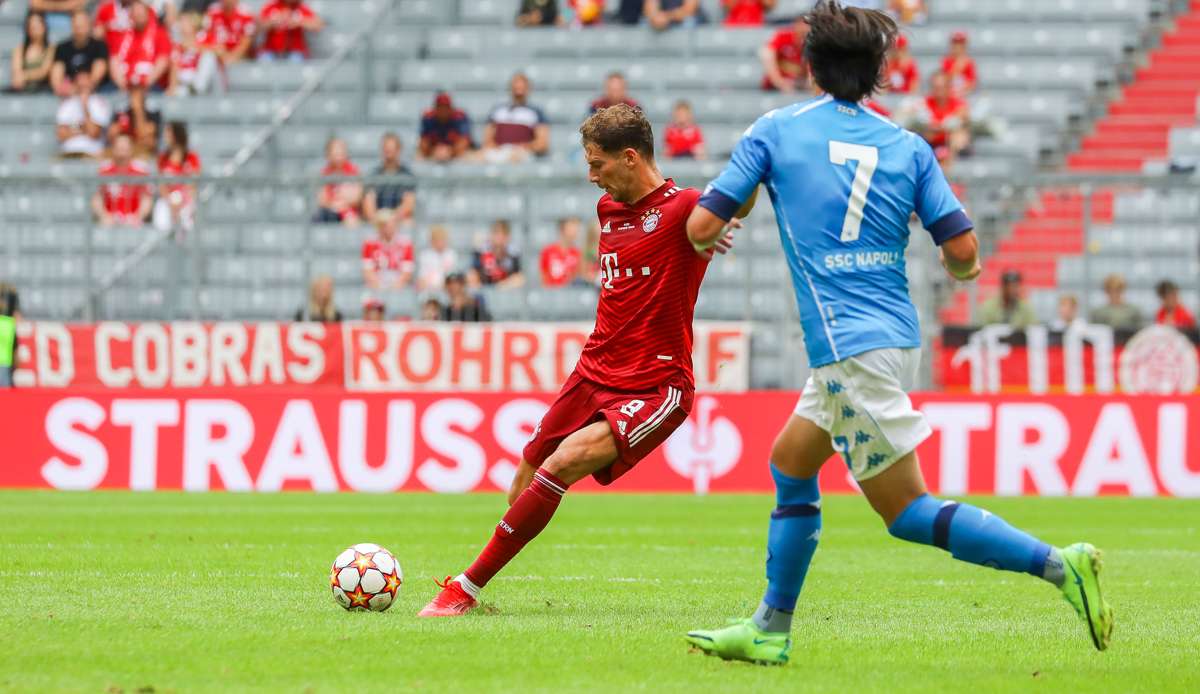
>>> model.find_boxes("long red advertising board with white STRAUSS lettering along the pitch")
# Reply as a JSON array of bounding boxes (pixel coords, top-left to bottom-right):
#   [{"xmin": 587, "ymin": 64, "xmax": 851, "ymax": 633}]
[{"xmin": 0, "ymin": 389, "xmax": 1200, "ymax": 497}]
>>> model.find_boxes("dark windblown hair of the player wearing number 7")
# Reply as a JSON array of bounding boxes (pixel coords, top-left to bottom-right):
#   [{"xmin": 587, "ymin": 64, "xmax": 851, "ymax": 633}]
[{"xmin": 804, "ymin": 0, "xmax": 899, "ymax": 102}]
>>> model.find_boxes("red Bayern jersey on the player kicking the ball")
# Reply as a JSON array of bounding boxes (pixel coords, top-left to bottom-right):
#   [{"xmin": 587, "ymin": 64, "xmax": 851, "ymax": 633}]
[{"xmin": 575, "ymin": 180, "xmax": 708, "ymax": 390}]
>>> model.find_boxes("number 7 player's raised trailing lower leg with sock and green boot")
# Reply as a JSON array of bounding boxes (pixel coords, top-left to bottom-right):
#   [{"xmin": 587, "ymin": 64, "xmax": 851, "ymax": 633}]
[{"xmin": 859, "ymin": 451, "xmax": 1112, "ymax": 651}]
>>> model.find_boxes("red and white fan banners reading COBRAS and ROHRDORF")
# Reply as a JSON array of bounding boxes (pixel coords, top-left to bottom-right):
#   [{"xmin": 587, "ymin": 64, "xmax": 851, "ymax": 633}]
[{"xmin": 14, "ymin": 322, "xmax": 750, "ymax": 393}]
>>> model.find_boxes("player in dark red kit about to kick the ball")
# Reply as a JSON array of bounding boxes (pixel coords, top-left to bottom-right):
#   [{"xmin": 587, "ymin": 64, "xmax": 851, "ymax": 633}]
[{"xmin": 419, "ymin": 104, "xmax": 737, "ymax": 609}]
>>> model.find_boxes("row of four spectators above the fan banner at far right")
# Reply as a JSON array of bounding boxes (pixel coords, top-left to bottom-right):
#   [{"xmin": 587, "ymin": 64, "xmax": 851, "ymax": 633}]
[{"xmin": 976, "ymin": 269, "xmax": 1196, "ymax": 333}]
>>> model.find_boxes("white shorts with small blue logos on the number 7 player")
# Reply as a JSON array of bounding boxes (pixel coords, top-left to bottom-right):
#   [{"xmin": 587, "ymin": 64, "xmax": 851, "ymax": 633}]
[{"xmin": 796, "ymin": 348, "xmax": 932, "ymax": 480}]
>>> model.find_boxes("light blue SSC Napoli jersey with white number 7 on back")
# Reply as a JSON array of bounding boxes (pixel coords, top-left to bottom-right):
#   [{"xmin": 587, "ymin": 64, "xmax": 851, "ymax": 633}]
[{"xmin": 700, "ymin": 96, "xmax": 973, "ymax": 366}]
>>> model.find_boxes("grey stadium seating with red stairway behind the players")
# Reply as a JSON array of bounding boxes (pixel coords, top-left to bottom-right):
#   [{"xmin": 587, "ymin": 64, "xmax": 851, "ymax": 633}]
[{"xmin": 0, "ymin": 0, "xmax": 1200, "ymax": 385}]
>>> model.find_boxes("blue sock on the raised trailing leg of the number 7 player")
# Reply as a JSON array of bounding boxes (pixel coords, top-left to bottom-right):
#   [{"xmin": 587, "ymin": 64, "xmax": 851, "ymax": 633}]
[{"xmin": 888, "ymin": 493, "xmax": 1061, "ymax": 582}]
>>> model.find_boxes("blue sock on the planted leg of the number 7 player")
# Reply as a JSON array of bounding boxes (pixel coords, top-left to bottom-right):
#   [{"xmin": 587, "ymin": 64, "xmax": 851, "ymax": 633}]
[{"xmin": 754, "ymin": 465, "xmax": 821, "ymax": 632}]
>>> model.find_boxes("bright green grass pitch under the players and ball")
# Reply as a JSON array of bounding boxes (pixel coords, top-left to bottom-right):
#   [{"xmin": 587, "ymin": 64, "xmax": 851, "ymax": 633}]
[{"xmin": 0, "ymin": 491, "xmax": 1200, "ymax": 694}]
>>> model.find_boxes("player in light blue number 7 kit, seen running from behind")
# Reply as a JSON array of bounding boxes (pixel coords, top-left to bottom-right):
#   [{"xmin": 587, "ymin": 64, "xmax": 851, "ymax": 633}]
[{"xmin": 686, "ymin": 1, "xmax": 1112, "ymax": 664}]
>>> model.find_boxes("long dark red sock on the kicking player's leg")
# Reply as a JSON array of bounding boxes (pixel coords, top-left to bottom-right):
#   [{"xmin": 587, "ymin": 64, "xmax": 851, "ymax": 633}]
[{"xmin": 463, "ymin": 468, "xmax": 566, "ymax": 588}]
